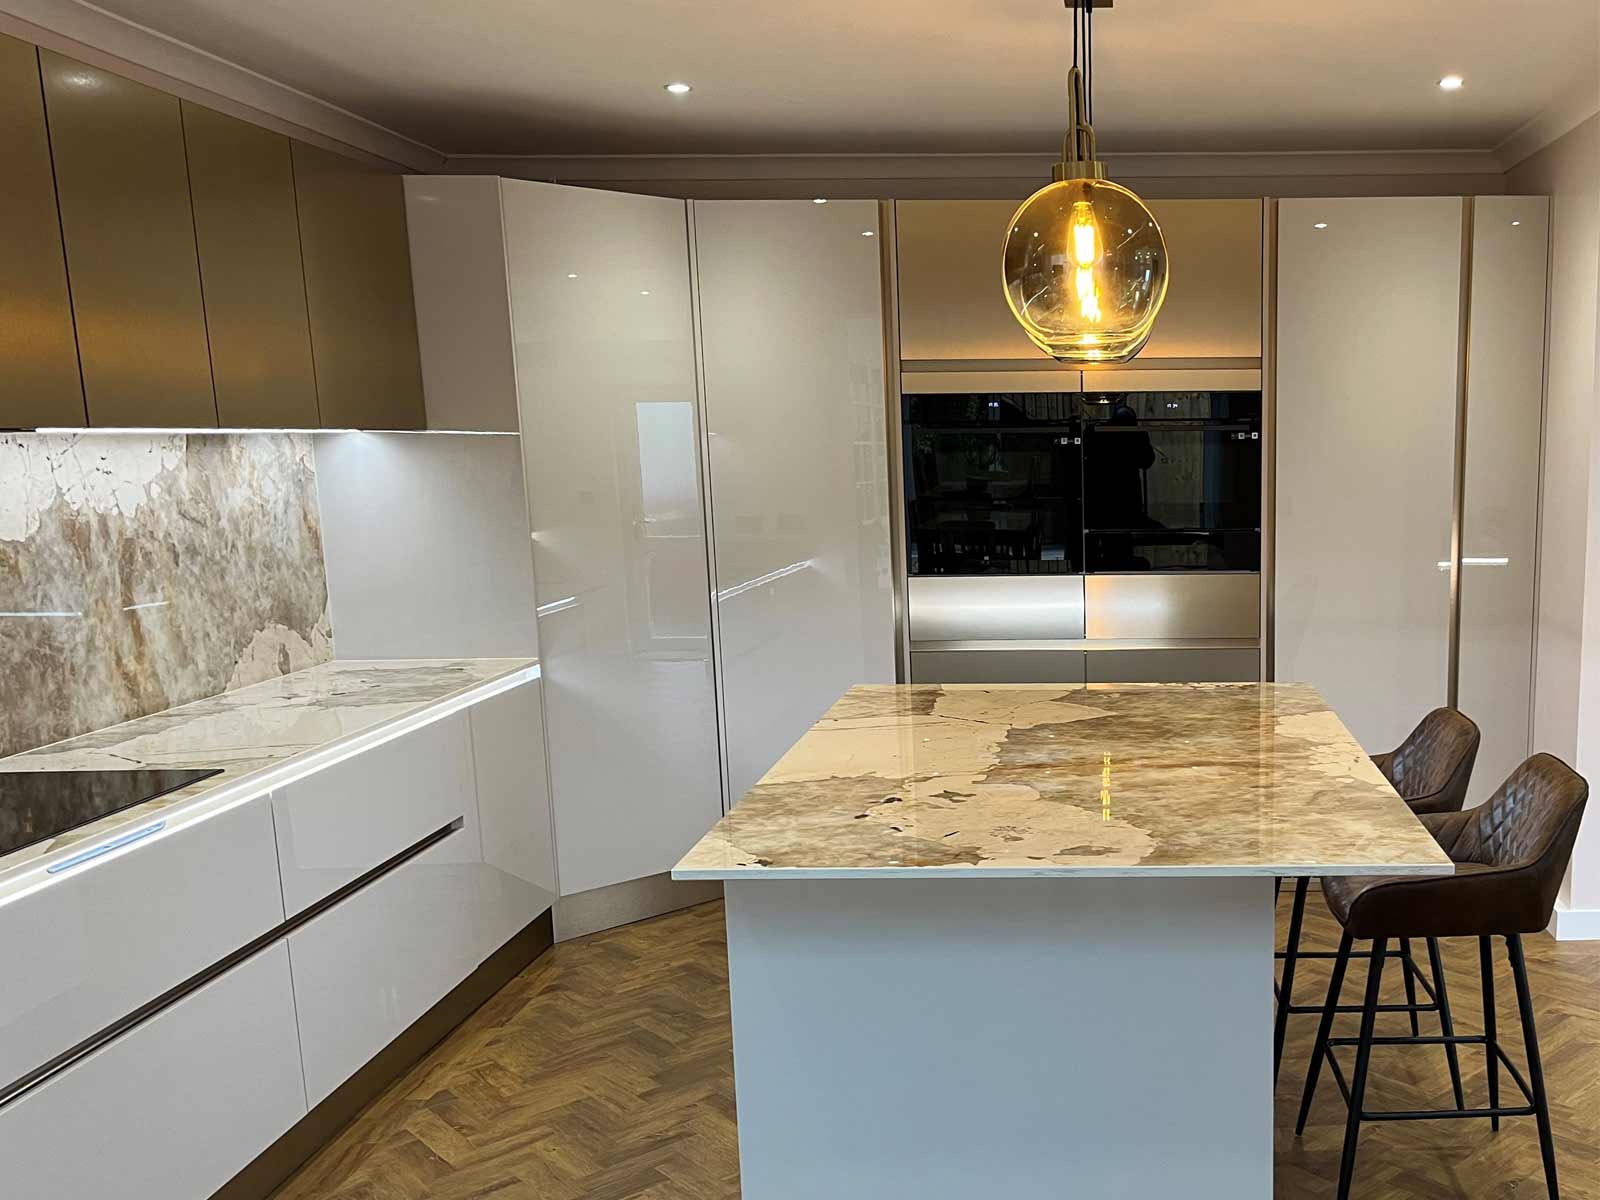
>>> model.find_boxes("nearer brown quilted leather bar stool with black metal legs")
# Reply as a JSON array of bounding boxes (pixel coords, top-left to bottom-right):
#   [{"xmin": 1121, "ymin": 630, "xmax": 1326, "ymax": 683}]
[{"xmin": 1294, "ymin": 754, "xmax": 1589, "ymax": 1200}]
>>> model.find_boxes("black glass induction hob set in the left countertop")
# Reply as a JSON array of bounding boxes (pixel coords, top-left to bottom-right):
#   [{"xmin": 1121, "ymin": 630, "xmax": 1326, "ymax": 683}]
[{"xmin": 0, "ymin": 768, "xmax": 222, "ymax": 854}]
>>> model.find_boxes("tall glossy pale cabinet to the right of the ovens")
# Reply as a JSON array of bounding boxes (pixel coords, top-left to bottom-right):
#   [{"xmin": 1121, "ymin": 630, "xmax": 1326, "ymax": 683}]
[{"xmin": 1274, "ymin": 197, "xmax": 1549, "ymax": 803}]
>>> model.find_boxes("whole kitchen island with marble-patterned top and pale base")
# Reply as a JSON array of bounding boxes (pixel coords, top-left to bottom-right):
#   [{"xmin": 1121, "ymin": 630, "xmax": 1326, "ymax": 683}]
[{"xmin": 674, "ymin": 685, "xmax": 1453, "ymax": 1200}]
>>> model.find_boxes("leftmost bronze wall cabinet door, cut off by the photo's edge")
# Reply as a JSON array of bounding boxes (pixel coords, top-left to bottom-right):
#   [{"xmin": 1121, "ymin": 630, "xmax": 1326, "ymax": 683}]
[{"xmin": 0, "ymin": 35, "xmax": 85, "ymax": 429}]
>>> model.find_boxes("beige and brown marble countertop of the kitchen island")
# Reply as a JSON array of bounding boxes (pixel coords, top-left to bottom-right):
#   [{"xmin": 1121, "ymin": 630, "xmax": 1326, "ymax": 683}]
[{"xmin": 672, "ymin": 683, "xmax": 1454, "ymax": 878}]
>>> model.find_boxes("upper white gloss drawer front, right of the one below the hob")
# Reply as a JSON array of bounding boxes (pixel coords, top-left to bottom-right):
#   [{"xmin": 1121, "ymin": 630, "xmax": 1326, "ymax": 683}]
[{"xmin": 272, "ymin": 712, "xmax": 475, "ymax": 917}]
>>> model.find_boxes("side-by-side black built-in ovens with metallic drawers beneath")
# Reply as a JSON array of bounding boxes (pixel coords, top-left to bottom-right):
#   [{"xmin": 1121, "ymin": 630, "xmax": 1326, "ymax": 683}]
[{"xmin": 902, "ymin": 390, "xmax": 1262, "ymax": 682}]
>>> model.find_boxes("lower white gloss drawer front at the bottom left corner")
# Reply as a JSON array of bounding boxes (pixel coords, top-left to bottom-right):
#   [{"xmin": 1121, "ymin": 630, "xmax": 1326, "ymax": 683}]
[{"xmin": 0, "ymin": 942, "xmax": 306, "ymax": 1200}]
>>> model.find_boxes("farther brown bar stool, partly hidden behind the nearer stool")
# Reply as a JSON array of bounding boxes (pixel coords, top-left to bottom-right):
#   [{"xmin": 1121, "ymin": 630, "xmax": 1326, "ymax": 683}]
[{"xmin": 1272, "ymin": 709, "xmax": 1483, "ymax": 1091}]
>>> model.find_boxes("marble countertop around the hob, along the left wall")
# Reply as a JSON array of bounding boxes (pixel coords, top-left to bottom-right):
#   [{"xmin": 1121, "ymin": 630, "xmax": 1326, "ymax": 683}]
[{"xmin": 0, "ymin": 658, "xmax": 538, "ymax": 899}]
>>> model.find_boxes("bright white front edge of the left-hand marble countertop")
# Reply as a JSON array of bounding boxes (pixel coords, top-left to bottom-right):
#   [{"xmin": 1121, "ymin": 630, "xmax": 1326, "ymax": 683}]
[{"xmin": 0, "ymin": 659, "xmax": 542, "ymax": 906}]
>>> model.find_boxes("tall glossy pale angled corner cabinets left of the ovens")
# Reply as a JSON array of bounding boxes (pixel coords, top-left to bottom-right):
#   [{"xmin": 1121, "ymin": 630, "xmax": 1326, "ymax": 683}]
[{"xmin": 406, "ymin": 176, "xmax": 894, "ymax": 938}]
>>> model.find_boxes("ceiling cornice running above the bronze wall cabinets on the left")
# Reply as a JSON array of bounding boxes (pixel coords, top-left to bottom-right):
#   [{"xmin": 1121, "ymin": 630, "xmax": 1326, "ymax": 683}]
[{"xmin": 0, "ymin": 0, "xmax": 446, "ymax": 171}]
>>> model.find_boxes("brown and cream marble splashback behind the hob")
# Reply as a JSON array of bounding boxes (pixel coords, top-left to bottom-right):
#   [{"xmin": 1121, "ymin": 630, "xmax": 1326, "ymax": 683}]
[{"xmin": 0, "ymin": 434, "xmax": 333, "ymax": 755}]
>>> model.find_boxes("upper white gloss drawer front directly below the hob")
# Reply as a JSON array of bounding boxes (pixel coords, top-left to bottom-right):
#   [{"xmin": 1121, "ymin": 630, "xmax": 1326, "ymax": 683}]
[{"xmin": 0, "ymin": 797, "xmax": 283, "ymax": 1100}]
